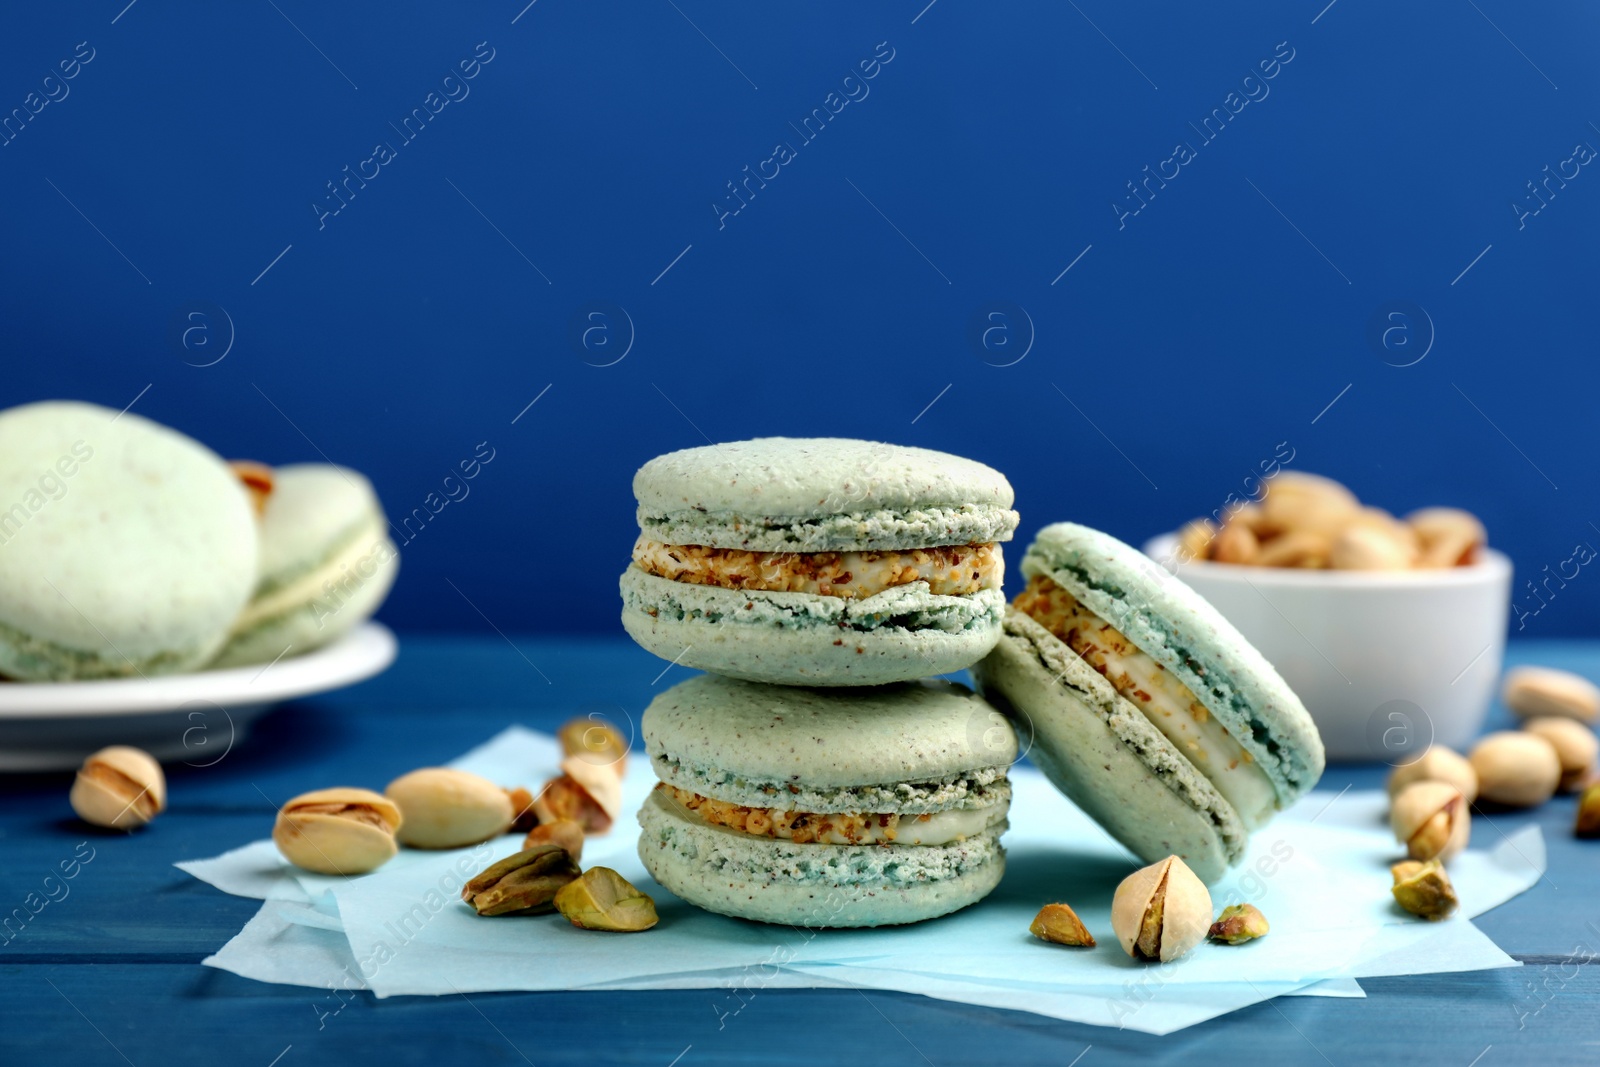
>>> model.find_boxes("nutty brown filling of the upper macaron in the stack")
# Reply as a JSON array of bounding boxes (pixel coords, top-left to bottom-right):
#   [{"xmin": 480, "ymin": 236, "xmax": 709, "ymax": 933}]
[{"xmin": 634, "ymin": 536, "xmax": 1005, "ymax": 600}]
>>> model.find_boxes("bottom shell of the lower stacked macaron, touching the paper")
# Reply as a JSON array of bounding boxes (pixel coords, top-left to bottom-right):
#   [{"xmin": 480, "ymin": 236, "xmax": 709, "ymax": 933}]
[{"xmin": 638, "ymin": 793, "xmax": 1005, "ymax": 928}]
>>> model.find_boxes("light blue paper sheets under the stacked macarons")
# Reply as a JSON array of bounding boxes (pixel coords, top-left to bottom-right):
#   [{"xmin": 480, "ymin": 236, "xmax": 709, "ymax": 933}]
[{"xmin": 178, "ymin": 728, "xmax": 1544, "ymax": 1033}]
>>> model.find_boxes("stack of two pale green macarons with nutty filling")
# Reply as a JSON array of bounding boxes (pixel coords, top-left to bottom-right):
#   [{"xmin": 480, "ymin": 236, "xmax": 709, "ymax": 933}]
[{"xmin": 621, "ymin": 438, "xmax": 1018, "ymax": 926}]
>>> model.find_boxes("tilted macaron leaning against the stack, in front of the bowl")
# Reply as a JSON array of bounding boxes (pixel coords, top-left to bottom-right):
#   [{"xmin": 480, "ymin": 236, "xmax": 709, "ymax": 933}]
[{"xmin": 973, "ymin": 523, "xmax": 1323, "ymax": 881}]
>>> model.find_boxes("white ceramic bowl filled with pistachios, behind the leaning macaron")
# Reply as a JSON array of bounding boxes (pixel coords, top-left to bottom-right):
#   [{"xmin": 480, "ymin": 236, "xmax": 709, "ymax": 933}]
[{"xmin": 1144, "ymin": 534, "xmax": 1510, "ymax": 763}]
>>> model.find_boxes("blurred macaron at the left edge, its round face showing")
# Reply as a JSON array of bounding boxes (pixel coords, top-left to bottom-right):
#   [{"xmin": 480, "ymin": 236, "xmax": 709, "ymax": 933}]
[{"xmin": 0, "ymin": 402, "xmax": 256, "ymax": 681}]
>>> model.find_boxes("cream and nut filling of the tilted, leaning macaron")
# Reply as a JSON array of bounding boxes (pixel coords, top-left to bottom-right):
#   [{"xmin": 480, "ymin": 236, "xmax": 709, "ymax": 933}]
[{"xmin": 1014, "ymin": 576, "xmax": 1278, "ymax": 830}]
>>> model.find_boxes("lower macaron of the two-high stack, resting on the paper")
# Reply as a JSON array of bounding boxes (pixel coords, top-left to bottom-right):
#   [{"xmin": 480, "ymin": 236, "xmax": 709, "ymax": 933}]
[{"xmin": 638, "ymin": 675, "xmax": 1018, "ymax": 926}]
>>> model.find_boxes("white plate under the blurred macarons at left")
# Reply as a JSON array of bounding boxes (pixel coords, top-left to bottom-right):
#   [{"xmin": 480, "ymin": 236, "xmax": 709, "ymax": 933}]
[{"xmin": 0, "ymin": 622, "xmax": 395, "ymax": 771}]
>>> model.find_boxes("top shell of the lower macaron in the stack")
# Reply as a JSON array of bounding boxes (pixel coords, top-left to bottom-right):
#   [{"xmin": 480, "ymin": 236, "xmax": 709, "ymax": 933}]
[{"xmin": 642, "ymin": 675, "xmax": 1018, "ymax": 813}]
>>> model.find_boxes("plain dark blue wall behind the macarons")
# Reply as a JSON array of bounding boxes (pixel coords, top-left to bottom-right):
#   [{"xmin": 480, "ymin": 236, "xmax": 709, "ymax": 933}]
[{"xmin": 0, "ymin": 0, "xmax": 1600, "ymax": 637}]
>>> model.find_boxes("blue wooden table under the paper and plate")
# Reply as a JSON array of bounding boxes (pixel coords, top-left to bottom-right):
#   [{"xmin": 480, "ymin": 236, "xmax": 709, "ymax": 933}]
[{"xmin": 0, "ymin": 637, "xmax": 1600, "ymax": 1067}]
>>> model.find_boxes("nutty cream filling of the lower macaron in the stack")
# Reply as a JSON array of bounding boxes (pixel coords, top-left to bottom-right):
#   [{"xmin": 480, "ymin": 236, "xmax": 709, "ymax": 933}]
[{"xmin": 656, "ymin": 782, "xmax": 1010, "ymax": 845}]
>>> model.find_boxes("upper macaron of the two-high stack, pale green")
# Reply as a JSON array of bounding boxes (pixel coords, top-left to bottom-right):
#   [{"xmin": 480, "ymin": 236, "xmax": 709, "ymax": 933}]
[{"xmin": 621, "ymin": 437, "xmax": 1018, "ymax": 686}]
